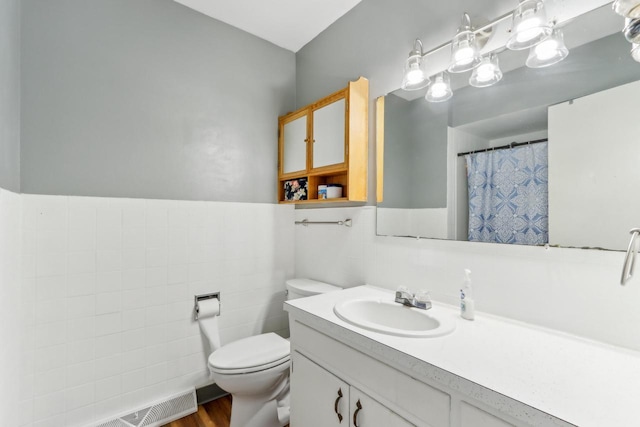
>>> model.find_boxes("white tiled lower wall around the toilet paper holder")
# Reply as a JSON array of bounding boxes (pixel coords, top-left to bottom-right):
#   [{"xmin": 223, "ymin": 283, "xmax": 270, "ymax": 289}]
[{"xmin": 17, "ymin": 195, "xmax": 294, "ymax": 426}]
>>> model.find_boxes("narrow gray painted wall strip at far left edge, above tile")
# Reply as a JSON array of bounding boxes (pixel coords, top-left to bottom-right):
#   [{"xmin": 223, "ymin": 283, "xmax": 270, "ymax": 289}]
[{"xmin": 0, "ymin": 0, "xmax": 20, "ymax": 192}]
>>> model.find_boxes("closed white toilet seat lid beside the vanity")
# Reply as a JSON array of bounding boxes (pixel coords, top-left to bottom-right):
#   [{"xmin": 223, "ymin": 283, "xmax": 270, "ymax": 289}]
[{"xmin": 208, "ymin": 332, "xmax": 291, "ymax": 375}]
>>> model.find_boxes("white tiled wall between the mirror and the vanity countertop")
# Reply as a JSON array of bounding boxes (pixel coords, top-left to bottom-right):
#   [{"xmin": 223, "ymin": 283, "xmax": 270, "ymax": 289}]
[{"xmin": 295, "ymin": 207, "xmax": 640, "ymax": 350}]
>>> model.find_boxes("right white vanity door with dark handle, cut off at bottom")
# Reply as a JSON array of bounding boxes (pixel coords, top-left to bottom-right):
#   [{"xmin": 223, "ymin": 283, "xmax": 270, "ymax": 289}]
[{"xmin": 350, "ymin": 387, "xmax": 413, "ymax": 427}]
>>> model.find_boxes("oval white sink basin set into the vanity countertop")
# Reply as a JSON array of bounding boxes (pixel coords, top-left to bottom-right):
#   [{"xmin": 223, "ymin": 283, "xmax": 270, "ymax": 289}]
[{"xmin": 333, "ymin": 298, "xmax": 456, "ymax": 338}]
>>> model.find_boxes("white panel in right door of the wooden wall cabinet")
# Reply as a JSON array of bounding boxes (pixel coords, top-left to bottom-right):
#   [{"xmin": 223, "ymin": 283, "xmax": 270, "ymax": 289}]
[{"xmin": 312, "ymin": 98, "xmax": 346, "ymax": 169}]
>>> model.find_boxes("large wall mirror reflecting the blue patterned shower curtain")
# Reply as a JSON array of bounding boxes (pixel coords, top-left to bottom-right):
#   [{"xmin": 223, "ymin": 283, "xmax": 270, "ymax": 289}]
[{"xmin": 377, "ymin": 6, "xmax": 640, "ymax": 250}]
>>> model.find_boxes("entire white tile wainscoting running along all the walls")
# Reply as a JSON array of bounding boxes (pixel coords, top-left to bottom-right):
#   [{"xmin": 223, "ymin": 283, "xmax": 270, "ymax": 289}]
[{"xmin": 11, "ymin": 195, "xmax": 640, "ymax": 426}]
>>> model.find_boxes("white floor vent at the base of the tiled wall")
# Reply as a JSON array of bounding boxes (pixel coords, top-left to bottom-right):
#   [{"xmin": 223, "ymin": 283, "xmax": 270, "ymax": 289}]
[{"xmin": 96, "ymin": 389, "xmax": 198, "ymax": 427}]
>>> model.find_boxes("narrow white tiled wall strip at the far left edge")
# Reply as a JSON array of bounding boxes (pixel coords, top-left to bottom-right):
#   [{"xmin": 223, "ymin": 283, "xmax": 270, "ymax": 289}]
[{"xmin": 0, "ymin": 189, "xmax": 22, "ymax": 425}]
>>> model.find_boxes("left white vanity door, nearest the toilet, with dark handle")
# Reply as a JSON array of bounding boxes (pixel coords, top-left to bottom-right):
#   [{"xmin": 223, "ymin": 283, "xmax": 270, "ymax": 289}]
[{"xmin": 291, "ymin": 351, "xmax": 350, "ymax": 427}]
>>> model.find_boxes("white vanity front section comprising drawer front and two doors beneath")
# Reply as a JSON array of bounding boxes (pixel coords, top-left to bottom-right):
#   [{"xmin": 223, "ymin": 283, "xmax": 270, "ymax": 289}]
[{"xmin": 290, "ymin": 321, "xmax": 451, "ymax": 427}]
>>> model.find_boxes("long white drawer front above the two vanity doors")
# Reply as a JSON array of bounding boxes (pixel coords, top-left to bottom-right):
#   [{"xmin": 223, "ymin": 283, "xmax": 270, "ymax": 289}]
[{"xmin": 290, "ymin": 322, "xmax": 451, "ymax": 427}]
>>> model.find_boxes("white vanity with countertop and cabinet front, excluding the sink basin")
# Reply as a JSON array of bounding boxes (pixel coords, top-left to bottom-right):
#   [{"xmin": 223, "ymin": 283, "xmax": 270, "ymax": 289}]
[{"xmin": 284, "ymin": 285, "xmax": 640, "ymax": 427}]
